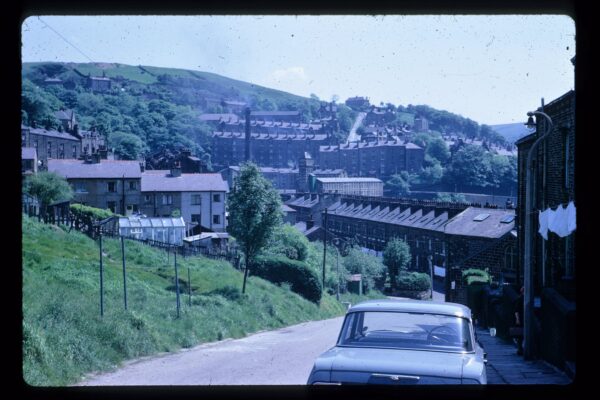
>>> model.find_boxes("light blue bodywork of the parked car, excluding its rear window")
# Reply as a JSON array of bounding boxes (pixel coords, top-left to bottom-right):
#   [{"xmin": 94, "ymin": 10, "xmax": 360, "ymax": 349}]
[{"xmin": 307, "ymin": 299, "xmax": 487, "ymax": 385}]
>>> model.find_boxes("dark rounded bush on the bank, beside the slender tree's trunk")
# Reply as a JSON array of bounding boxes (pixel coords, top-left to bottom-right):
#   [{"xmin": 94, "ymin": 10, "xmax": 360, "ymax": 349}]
[{"xmin": 251, "ymin": 256, "xmax": 322, "ymax": 303}]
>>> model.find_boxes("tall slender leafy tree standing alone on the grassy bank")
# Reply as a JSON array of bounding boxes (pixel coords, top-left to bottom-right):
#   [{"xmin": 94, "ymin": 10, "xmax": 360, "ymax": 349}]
[{"xmin": 229, "ymin": 162, "xmax": 281, "ymax": 293}]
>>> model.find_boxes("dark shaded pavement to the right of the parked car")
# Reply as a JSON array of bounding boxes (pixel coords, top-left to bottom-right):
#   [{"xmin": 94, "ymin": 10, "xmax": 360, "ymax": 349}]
[{"xmin": 475, "ymin": 328, "xmax": 572, "ymax": 385}]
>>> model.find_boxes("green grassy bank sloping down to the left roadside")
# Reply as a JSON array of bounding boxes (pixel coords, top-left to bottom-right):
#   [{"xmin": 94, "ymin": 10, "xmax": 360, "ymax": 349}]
[{"xmin": 22, "ymin": 217, "xmax": 352, "ymax": 386}]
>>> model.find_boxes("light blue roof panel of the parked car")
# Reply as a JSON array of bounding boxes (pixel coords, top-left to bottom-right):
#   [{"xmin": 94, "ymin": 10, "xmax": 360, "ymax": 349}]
[{"xmin": 348, "ymin": 299, "xmax": 471, "ymax": 319}]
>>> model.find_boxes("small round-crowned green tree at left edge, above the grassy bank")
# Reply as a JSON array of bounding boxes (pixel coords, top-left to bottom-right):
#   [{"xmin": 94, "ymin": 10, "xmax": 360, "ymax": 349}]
[{"xmin": 23, "ymin": 172, "xmax": 73, "ymax": 216}]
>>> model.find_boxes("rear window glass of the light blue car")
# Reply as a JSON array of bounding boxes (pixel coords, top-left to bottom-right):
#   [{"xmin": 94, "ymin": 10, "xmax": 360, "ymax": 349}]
[{"xmin": 338, "ymin": 311, "xmax": 473, "ymax": 352}]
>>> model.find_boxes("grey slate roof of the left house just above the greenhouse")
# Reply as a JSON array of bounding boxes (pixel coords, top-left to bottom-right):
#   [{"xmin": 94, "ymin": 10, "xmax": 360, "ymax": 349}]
[{"xmin": 48, "ymin": 159, "xmax": 142, "ymax": 179}]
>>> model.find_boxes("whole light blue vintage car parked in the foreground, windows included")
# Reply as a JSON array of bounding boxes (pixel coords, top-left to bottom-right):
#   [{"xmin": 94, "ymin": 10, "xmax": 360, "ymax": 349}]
[{"xmin": 307, "ymin": 299, "xmax": 487, "ymax": 385}]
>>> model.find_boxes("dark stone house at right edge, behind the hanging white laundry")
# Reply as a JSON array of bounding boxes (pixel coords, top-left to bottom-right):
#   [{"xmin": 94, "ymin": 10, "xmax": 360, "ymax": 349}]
[{"xmin": 515, "ymin": 88, "xmax": 577, "ymax": 373}]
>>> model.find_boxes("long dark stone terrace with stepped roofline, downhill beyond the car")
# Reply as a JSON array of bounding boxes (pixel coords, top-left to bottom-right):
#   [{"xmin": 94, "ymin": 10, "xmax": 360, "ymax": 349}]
[{"xmin": 321, "ymin": 196, "xmax": 517, "ymax": 303}]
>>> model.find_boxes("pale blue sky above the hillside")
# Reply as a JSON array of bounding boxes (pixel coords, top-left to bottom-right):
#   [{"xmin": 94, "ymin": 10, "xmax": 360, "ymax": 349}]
[{"xmin": 21, "ymin": 15, "xmax": 575, "ymax": 125}]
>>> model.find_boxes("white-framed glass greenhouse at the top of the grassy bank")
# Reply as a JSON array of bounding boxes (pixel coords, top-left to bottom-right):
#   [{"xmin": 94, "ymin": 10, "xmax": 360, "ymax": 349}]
[{"xmin": 119, "ymin": 217, "xmax": 185, "ymax": 246}]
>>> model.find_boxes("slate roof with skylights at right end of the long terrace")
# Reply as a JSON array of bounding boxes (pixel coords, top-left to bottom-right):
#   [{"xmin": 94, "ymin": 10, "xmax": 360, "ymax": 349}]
[{"xmin": 445, "ymin": 207, "xmax": 515, "ymax": 238}]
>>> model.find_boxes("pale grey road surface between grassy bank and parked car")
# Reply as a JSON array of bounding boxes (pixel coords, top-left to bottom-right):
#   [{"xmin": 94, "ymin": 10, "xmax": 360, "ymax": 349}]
[{"xmin": 78, "ymin": 317, "xmax": 343, "ymax": 386}]
